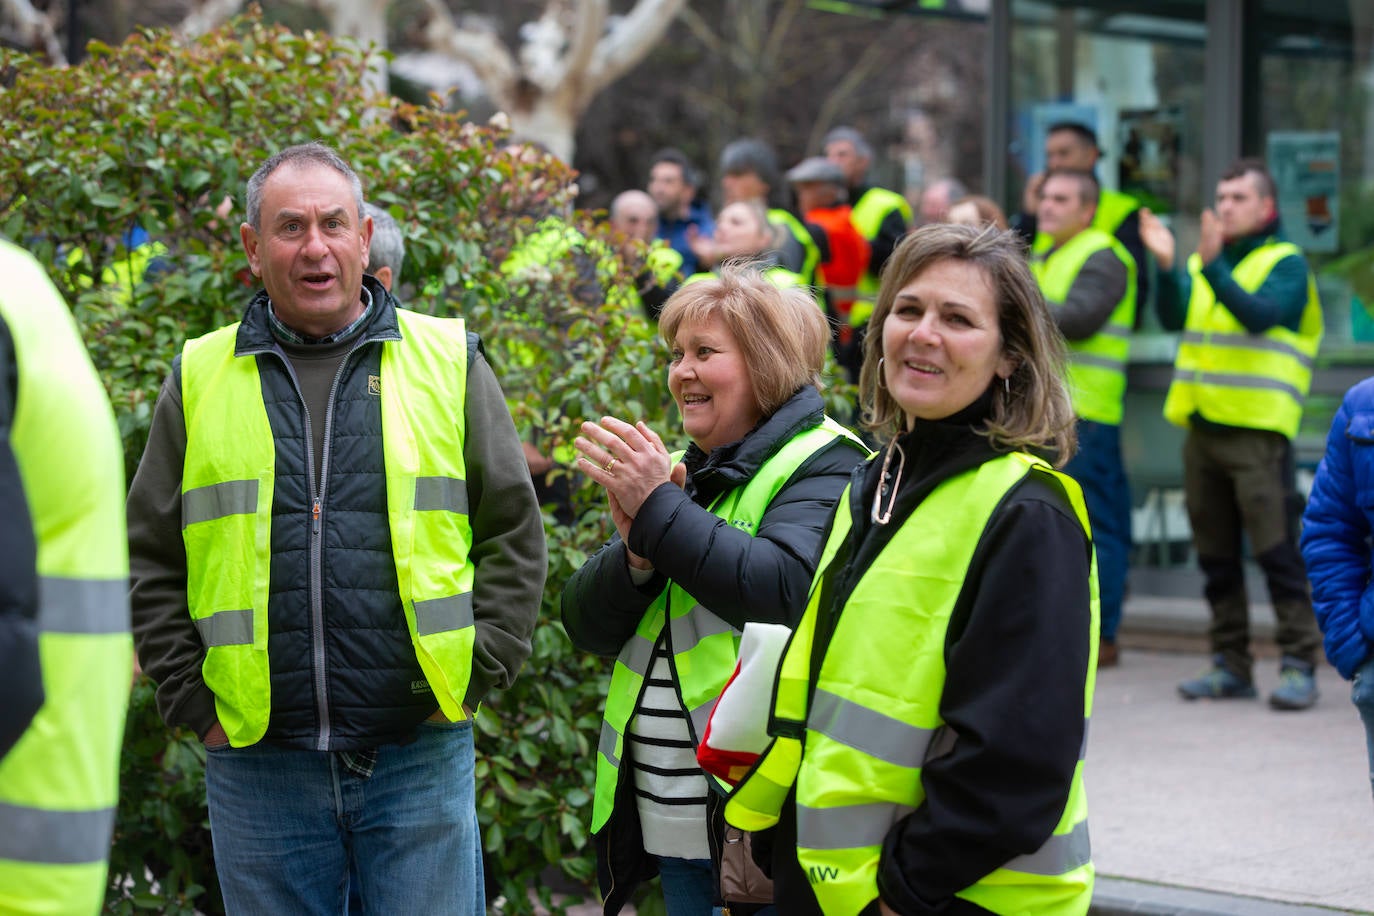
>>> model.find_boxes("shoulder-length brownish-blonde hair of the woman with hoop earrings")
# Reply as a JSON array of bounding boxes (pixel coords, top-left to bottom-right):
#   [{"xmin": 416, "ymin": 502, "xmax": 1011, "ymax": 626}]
[{"xmin": 859, "ymin": 222, "xmax": 1077, "ymax": 467}]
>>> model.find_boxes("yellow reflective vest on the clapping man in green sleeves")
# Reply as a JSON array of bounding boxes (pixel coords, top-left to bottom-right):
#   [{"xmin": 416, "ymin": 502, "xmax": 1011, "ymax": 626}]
[{"xmin": 1164, "ymin": 240, "xmax": 1323, "ymax": 439}]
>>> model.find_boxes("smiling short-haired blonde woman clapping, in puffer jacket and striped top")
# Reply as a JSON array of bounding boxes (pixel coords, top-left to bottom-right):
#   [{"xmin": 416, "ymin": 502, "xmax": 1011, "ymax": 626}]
[{"xmin": 562, "ymin": 268, "xmax": 867, "ymax": 916}]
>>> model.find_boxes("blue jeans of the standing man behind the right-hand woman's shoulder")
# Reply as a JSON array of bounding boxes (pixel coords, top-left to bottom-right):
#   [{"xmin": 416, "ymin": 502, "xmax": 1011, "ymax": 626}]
[{"xmin": 1063, "ymin": 420, "xmax": 1131, "ymax": 643}]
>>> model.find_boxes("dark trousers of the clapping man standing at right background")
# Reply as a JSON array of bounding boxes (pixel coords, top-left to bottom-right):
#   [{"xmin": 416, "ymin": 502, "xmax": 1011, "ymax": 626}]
[{"xmin": 1183, "ymin": 424, "xmax": 1322, "ymax": 677}]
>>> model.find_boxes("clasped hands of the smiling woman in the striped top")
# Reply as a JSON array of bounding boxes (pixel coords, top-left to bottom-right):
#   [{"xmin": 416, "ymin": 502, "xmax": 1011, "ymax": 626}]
[{"xmin": 573, "ymin": 416, "xmax": 687, "ymax": 570}]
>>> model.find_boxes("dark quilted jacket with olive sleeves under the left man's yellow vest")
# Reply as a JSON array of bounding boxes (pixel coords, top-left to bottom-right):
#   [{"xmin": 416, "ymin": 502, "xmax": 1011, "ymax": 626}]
[{"xmin": 128, "ymin": 276, "xmax": 547, "ymax": 751}]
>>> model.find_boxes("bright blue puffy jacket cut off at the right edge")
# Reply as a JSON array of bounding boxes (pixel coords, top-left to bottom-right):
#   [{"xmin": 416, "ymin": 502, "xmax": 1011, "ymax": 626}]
[{"xmin": 1303, "ymin": 379, "xmax": 1374, "ymax": 680}]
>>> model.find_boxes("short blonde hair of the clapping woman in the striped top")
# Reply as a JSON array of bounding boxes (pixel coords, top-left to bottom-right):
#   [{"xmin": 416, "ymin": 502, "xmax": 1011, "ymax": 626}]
[{"xmin": 658, "ymin": 261, "xmax": 830, "ymax": 416}]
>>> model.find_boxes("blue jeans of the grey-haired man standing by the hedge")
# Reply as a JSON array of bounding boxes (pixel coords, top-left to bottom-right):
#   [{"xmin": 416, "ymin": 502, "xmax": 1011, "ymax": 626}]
[{"xmin": 205, "ymin": 720, "xmax": 486, "ymax": 916}]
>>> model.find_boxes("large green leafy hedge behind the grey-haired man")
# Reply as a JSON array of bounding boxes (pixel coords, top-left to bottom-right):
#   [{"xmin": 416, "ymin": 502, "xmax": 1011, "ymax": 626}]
[{"xmin": 0, "ymin": 10, "xmax": 673, "ymax": 913}]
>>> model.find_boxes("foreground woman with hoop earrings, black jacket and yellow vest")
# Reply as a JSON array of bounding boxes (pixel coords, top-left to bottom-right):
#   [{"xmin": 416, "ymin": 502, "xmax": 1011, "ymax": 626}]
[{"xmin": 725, "ymin": 225, "xmax": 1098, "ymax": 916}]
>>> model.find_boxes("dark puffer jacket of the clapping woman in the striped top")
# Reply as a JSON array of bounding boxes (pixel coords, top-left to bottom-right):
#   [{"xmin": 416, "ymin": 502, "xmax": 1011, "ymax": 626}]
[{"xmin": 562, "ymin": 386, "xmax": 866, "ymax": 913}]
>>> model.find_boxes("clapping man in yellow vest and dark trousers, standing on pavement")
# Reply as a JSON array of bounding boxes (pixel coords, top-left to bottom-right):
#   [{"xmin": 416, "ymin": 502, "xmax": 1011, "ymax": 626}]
[{"xmin": 1140, "ymin": 159, "xmax": 1323, "ymax": 711}]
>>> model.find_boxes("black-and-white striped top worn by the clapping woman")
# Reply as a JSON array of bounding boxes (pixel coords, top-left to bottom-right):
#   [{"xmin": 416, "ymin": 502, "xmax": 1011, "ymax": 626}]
[{"xmin": 627, "ymin": 630, "xmax": 710, "ymax": 858}]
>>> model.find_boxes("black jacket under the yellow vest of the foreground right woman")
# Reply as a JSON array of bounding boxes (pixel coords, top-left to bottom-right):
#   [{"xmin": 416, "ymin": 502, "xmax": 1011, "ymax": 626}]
[{"xmin": 754, "ymin": 394, "xmax": 1091, "ymax": 916}]
